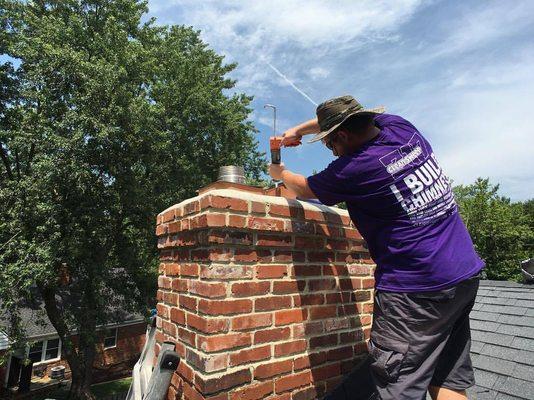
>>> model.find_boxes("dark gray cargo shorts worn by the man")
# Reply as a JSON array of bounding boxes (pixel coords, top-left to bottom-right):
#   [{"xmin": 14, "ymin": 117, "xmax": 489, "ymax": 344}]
[{"xmin": 368, "ymin": 273, "xmax": 480, "ymax": 400}]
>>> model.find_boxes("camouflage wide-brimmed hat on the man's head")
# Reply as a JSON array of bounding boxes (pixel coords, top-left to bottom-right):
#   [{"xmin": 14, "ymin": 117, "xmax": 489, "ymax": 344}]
[{"xmin": 308, "ymin": 95, "xmax": 385, "ymax": 143}]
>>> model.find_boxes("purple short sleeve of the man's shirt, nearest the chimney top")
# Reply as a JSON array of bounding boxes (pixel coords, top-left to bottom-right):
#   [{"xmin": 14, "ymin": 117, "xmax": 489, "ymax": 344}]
[{"xmin": 307, "ymin": 157, "xmax": 350, "ymax": 206}]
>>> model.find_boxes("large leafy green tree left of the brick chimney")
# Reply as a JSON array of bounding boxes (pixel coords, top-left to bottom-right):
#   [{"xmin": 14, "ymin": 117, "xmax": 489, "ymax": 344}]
[{"xmin": 0, "ymin": 0, "xmax": 266, "ymax": 399}]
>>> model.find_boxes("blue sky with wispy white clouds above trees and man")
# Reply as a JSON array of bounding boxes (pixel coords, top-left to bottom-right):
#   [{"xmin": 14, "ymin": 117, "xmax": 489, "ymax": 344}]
[{"xmin": 149, "ymin": 0, "xmax": 534, "ymax": 200}]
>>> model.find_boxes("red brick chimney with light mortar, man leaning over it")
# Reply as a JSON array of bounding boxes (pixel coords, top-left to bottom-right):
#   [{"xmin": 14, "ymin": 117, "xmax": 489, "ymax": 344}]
[{"xmin": 156, "ymin": 184, "xmax": 374, "ymax": 400}]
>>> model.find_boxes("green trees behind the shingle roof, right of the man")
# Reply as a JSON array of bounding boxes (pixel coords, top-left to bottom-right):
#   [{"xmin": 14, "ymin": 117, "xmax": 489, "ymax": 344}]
[{"xmin": 454, "ymin": 178, "xmax": 534, "ymax": 280}]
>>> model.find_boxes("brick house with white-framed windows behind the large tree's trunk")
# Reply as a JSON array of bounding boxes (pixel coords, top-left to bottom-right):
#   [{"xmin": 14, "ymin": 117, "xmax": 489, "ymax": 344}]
[{"xmin": 0, "ymin": 304, "xmax": 147, "ymax": 393}]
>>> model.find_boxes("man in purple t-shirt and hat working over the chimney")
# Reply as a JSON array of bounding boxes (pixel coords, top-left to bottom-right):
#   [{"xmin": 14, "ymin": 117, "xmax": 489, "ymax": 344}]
[{"xmin": 269, "ymin": 96, "xmax": 484, "ymax": 400}]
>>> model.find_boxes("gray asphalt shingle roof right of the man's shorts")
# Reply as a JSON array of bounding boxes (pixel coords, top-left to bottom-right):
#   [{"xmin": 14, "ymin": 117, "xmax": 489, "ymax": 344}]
[{"xmin": 452, "ymin": 280, "xmax": 534, "ymax": 400}]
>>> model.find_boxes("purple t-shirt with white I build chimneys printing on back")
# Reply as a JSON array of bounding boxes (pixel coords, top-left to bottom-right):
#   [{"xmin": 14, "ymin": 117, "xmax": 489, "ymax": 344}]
[{"xmin": 308, "ymin": 114, "xmax": 484, "ymax": 292}]
